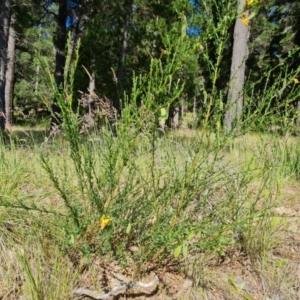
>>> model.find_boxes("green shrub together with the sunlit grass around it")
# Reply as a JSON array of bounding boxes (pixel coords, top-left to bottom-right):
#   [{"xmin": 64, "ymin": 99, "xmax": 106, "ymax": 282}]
[{"xmin": 0, "ymin": 4, "xmax": 300, "ymax": 300}]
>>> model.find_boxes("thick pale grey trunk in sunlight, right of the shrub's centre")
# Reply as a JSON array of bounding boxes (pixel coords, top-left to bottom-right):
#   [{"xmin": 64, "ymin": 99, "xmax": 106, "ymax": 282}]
[{"xmin": 224, "ymin": 0, "xmax": 249, "ymax": 132}]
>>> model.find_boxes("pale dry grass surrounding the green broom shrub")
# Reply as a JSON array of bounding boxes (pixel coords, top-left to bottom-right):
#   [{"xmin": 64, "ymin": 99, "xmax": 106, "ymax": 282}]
[{"xmin": 0, "ymin": 130, "xmax": 300, "ymax": 300}]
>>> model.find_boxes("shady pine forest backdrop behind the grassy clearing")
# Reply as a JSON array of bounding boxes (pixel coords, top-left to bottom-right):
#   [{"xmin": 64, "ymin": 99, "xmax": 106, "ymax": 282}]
[{"xmin": 0, "ymin": 1, "xmax": 300, "ymax": 129}]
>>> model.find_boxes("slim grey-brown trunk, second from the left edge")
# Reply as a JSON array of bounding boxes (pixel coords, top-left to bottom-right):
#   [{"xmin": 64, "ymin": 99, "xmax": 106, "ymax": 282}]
[{"xmin": 5, "ymin": 14, "xmax": 16, "ymax": 131}]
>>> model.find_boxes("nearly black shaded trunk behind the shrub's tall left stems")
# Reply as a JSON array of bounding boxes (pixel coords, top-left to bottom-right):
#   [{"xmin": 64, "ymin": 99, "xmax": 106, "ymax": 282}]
[{"xmin": 51, "ymin": 0, "xmax": 68, "ymax": 126}]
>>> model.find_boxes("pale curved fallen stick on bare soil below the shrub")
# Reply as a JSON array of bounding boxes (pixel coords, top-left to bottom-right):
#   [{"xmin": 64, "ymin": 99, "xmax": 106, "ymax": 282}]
[{"xmin": 74, "ymin": 275, "xmax": 158, "ymax": 299}]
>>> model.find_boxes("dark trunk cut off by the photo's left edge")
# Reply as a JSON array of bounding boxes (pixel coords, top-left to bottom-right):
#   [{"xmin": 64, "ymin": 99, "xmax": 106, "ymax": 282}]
[{"xmin": 0, "ymin": 0, "xmax": 11, "ymax": 130}]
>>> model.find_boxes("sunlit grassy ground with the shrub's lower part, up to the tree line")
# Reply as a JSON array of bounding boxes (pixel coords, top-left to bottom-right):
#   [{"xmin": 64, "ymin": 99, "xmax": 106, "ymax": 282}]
[{"xmin": 0, "ymin": 128, "xmax": 300, "ymax": 300}]
